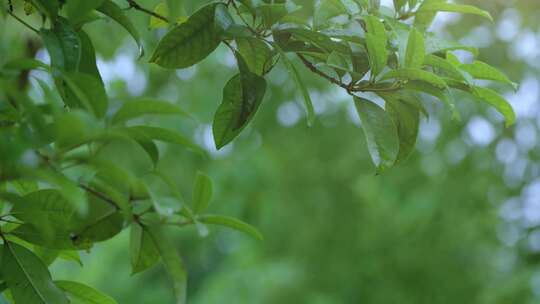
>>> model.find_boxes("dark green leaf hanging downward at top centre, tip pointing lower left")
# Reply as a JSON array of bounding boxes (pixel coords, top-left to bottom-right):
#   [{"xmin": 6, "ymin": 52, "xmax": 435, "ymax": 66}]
[{"xmin": 212, "ymin": 53, "xmax": 266, "ymax": 149}]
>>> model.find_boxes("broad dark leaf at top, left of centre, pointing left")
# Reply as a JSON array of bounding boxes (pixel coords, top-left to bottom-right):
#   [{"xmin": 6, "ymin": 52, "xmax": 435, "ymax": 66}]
[{"xmin": 150, "ymin": 3, "xmax": 221, "ymax": 69}]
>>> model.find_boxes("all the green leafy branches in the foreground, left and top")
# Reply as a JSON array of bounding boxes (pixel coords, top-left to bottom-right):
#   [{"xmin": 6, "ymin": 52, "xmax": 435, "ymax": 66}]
[{"xmin": 0, "ymin": 0, "xmax": 515, "ymax": 304}]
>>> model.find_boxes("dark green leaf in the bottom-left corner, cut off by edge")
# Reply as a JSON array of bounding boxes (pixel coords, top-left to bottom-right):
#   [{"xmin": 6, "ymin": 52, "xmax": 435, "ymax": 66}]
[{"xmin": 0, "ymin": 243, "xmax": 69, "ymax": 304}]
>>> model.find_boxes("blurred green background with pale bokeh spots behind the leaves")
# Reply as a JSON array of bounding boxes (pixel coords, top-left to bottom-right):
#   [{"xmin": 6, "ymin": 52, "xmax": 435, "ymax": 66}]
[{"xmin": 0, "ymin": 0, "xmax": 540, "ymax": 304}]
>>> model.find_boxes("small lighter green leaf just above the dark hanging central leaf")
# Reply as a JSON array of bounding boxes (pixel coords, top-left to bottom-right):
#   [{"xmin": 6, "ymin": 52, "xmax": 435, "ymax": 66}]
[{"xmin": 236, "ymin": 38, "xmax": 273, "ymax": 76}]
